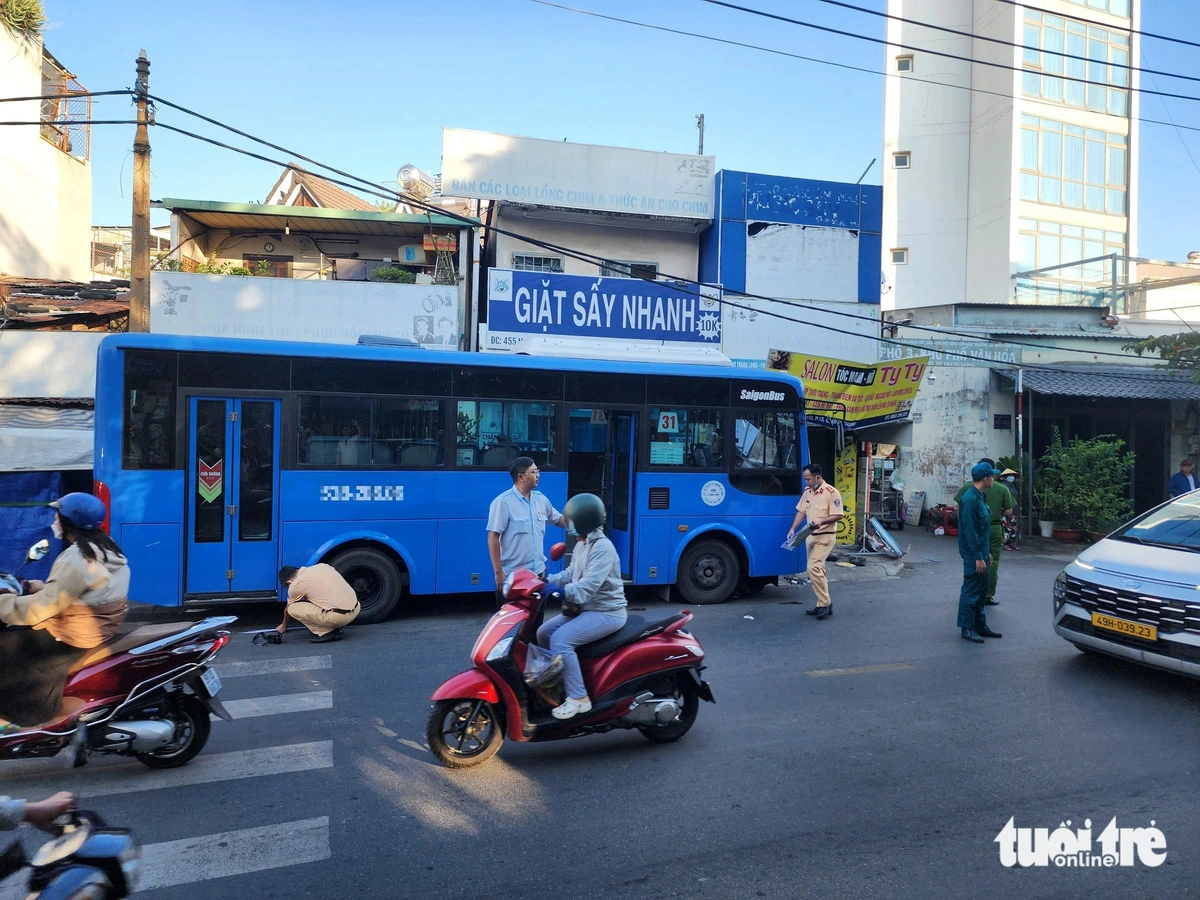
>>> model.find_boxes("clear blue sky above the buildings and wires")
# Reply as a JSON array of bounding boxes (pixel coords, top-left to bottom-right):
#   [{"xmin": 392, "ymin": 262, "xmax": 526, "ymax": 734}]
[{"xmin": 37, "ymin": 0, "xmax": 1200, "ymax": 259}]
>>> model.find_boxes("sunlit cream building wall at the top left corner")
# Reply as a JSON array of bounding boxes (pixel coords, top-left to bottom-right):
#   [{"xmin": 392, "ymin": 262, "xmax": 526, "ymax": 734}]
[{"xmin": 0, "ymin": 28, "xmax": 91, "ymax": 281}]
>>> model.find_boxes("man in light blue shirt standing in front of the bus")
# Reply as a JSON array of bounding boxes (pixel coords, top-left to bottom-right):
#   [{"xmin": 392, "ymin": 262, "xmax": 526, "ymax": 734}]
[{"xmin": 487, "ymin": 456, "xmax": 566, "ymax": 608}]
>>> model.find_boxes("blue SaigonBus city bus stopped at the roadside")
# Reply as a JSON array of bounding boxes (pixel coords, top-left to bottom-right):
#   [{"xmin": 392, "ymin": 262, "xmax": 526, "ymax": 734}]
[{"xmin": 95, "ymin": 335, "xmax": 808, "ymax": 622}]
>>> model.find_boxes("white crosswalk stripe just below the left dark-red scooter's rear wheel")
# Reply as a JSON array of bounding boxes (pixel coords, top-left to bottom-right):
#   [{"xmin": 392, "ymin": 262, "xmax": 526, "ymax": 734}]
[{"xmin": 4, "ymin": 740, "xmax": 334, "ymax": 798}]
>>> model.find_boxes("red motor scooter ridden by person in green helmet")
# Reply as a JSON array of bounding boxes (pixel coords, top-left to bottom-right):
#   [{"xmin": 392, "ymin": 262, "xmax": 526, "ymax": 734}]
[{"xmin": 425, "ymin": 547, "xmax": 715, "ymax": 768}]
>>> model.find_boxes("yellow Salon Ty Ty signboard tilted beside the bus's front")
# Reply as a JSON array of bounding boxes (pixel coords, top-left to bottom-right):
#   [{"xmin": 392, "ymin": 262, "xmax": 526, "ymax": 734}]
[{"xmin": 767, "ymin": 350, "xmax": 929, "ymax": 430}]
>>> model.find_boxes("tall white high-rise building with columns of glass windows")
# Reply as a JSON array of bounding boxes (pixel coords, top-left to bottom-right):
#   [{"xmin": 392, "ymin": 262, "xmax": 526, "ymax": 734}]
[{"xmin": 882, "ymin": 0, "xmax": 1139, "ymax": 311}]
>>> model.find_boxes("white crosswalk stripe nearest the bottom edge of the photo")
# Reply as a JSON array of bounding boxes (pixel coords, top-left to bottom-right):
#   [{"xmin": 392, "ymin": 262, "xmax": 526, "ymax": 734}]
[{"xmin": 138, "ymin": 816, "xmax": 330, "ymax": 890}]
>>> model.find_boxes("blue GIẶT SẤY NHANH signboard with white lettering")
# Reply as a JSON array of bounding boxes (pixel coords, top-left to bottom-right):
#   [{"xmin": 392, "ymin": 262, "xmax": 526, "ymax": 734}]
[{"xmin": 487, "ymin": 269, "xmax": 721, "ymax": 350}]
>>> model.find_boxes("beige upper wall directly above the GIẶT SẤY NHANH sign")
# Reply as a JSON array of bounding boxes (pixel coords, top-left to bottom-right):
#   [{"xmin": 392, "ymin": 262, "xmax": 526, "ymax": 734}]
[{"xmin": 496, "ymin": 205, "xmax": 700, "ymax": 278}]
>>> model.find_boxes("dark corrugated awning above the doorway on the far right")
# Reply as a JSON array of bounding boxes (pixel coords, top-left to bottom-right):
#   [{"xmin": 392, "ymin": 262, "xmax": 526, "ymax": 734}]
[{"xmin": 995, "ymin": 365, "xmax": 1200, "ymax": 400}]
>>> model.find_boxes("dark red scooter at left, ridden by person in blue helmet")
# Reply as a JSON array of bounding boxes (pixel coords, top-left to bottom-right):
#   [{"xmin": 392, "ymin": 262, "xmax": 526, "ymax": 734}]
[{"xmin": 0, "ymin": 541, "xmax": 238, "ymax": 769}]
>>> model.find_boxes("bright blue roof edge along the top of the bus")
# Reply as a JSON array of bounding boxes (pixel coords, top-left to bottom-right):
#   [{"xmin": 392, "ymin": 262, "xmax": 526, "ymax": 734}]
[{"xmin": 100, "ymin": 334, "xmax": 804, "ymax": 396}]
